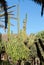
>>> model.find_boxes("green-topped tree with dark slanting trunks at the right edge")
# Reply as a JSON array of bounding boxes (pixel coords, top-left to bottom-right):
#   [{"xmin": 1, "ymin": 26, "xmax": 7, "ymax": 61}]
[{"xmin": 35, "ymin": 31, "xmax": 44, "ymax": 65}]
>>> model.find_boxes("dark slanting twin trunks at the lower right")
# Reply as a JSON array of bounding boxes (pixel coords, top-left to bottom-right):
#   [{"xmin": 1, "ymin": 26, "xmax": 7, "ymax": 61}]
[{"xmin": 35, "ymin": 39, "xmax": 44, "ymax": 65}]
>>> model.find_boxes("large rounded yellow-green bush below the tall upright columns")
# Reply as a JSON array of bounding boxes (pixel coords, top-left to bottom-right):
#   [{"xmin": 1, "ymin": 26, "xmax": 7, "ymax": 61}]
[{"xmin": 4, "ymin": 34, "xmax": 30, "ymax": 62}]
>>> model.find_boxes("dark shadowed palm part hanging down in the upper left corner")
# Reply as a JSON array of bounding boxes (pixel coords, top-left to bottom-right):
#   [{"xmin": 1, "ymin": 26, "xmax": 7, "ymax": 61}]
[{"xmin": 0, "ymin": 0, "xmax": 8, "ymax": 29}]
